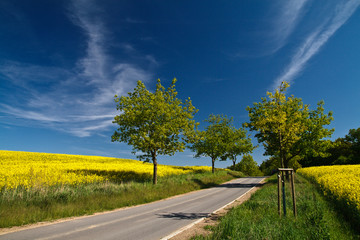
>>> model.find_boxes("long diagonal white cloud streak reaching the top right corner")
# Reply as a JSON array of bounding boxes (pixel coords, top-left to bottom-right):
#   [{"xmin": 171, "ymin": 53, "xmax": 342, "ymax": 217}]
[{"xmin": 272, "ymin": 0, "xmax": 360, "ymax": 89}]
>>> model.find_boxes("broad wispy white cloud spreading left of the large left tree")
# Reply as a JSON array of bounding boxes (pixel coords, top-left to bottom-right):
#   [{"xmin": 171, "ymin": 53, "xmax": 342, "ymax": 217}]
[{"xmin": 0, "ymin": 0, "xmax": 156, "ymax": 137}]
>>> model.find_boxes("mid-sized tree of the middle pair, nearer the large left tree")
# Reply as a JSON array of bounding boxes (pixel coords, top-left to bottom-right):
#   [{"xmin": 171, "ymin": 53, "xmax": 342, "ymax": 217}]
[{"xmin": 189, "ymin": 114, "xmax": 232, "ymax": 173}]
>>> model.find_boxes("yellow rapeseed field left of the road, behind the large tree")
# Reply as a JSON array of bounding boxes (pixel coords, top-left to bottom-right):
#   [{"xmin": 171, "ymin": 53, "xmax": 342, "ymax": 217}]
[{"xmin": 0, "ymin": 150, "xmax": 211, "ymax": 190}]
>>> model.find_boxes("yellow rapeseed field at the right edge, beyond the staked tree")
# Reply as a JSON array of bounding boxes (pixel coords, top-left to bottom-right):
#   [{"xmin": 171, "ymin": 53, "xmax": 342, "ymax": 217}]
[{"xmin": 298, "ymin": 165, "xmax": 360, "ymax": 213}]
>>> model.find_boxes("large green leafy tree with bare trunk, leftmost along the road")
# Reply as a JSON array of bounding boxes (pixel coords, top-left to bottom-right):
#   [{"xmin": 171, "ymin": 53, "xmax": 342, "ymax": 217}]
[{"xmin": 112, "ymin": 78, "xmax": 198, "ymax": 184}]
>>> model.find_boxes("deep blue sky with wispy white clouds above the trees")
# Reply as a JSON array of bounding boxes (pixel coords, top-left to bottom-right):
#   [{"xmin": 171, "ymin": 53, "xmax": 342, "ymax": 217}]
[{"xmin": 0, "ymin": 0, "xmax": 360, "ymax": 167}]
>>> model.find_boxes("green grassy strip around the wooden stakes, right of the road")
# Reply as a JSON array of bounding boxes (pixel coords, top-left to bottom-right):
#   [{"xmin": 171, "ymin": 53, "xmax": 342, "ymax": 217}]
[{"xmin": 194, "ymin": 175, "xmax": 359, "ymax": 240}]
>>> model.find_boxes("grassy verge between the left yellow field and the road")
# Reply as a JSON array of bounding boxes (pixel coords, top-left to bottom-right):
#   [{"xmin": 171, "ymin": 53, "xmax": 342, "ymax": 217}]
[{"xmin": 0, "ymin": 170, "xmax": 243, "ymax": 228}]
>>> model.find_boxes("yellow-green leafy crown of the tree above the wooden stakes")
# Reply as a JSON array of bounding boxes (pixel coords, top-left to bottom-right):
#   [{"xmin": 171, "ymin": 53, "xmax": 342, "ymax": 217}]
[{"xmin": 245, "ymin": 82, "xmax": 334, "ymax": 168}]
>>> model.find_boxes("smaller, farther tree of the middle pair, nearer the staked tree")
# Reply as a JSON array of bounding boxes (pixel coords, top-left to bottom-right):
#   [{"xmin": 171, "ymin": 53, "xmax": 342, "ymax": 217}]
[{"xmin": 224, "ymin": 126, "xmax": 256, "ymax": 168}]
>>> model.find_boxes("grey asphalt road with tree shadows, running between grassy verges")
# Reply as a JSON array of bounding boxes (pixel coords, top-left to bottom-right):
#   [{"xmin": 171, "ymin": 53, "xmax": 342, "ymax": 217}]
[{"xmin": 0, "ymin": 178, "xmax": 263, "ymax": 240}]
